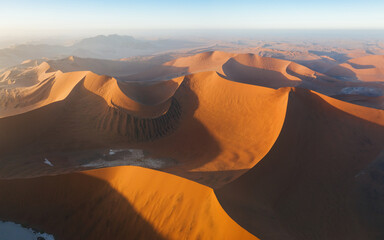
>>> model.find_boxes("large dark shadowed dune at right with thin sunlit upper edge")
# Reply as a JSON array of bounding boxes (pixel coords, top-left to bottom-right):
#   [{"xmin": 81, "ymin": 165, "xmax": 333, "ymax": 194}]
[{"xmin": 216, "ymin": 89, "xmax": 384, "ymax": 240}]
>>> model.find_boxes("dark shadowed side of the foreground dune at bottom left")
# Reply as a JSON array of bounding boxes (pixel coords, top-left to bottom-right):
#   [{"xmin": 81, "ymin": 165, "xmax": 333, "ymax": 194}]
[{"xmin": 0, "ymin": 173, "xmax": 164, "ymax": 239}]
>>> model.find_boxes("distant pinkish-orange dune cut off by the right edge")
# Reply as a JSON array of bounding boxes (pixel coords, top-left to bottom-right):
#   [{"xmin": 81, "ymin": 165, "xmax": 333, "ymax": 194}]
[{"xmin": 327, "ymin": 55, "xmax": 384, "ymax": 82}]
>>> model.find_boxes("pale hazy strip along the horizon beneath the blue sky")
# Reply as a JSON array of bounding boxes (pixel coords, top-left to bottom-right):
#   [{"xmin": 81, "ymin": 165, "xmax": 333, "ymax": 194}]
[{"xmin": 0, "ymin": 29, "xmax": 384, "ymax": 48}]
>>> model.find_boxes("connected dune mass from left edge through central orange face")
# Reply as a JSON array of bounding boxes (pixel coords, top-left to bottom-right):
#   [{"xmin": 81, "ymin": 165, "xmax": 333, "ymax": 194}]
[{"xmin": 0, "ymin": 67, "xmax": 288, "ymax": 186}]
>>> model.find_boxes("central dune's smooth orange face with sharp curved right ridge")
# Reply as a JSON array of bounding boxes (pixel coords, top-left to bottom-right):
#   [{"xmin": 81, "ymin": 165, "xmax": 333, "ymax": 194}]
[{"xmin": 144, "ymin": 72, "xmax": 288, "ymax": 186}]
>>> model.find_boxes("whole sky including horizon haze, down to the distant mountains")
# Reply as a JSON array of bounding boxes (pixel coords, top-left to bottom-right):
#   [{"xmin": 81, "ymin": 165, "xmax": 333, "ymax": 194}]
[{"xmin": 0, "ymin": 0, "xmax": 384, "ymax": 48}]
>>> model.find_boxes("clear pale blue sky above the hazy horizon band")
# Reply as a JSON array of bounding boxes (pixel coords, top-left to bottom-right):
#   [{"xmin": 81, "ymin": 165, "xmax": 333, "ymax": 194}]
[{"xmin": 0, "ymin": 0, "xmax": 384, "ymax": 35}]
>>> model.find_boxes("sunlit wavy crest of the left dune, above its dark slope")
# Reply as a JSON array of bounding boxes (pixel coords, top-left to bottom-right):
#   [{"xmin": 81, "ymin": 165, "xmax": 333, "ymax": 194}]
[{"xmin": 0, "ymin": 63, "xmax": 178, "ymax": 118}]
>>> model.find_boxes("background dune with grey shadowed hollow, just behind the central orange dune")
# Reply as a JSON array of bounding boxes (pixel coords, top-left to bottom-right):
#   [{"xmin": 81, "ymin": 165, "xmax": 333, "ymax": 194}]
[{"xmin": 164, "ymin": 51, "xmax": 328, "ymax": 88}]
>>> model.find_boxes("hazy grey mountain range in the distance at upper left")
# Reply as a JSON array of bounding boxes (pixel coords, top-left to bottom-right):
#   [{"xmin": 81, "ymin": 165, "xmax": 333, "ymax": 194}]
[{"xmin": 0, "ymin": 34, "xmax": 202, "ymax": 69}]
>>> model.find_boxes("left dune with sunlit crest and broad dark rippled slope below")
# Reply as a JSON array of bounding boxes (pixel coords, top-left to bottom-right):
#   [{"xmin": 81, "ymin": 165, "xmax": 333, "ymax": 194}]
[{"xmin": 0, "ymin": 64, "xmax": 180, "ymax": 177}]
